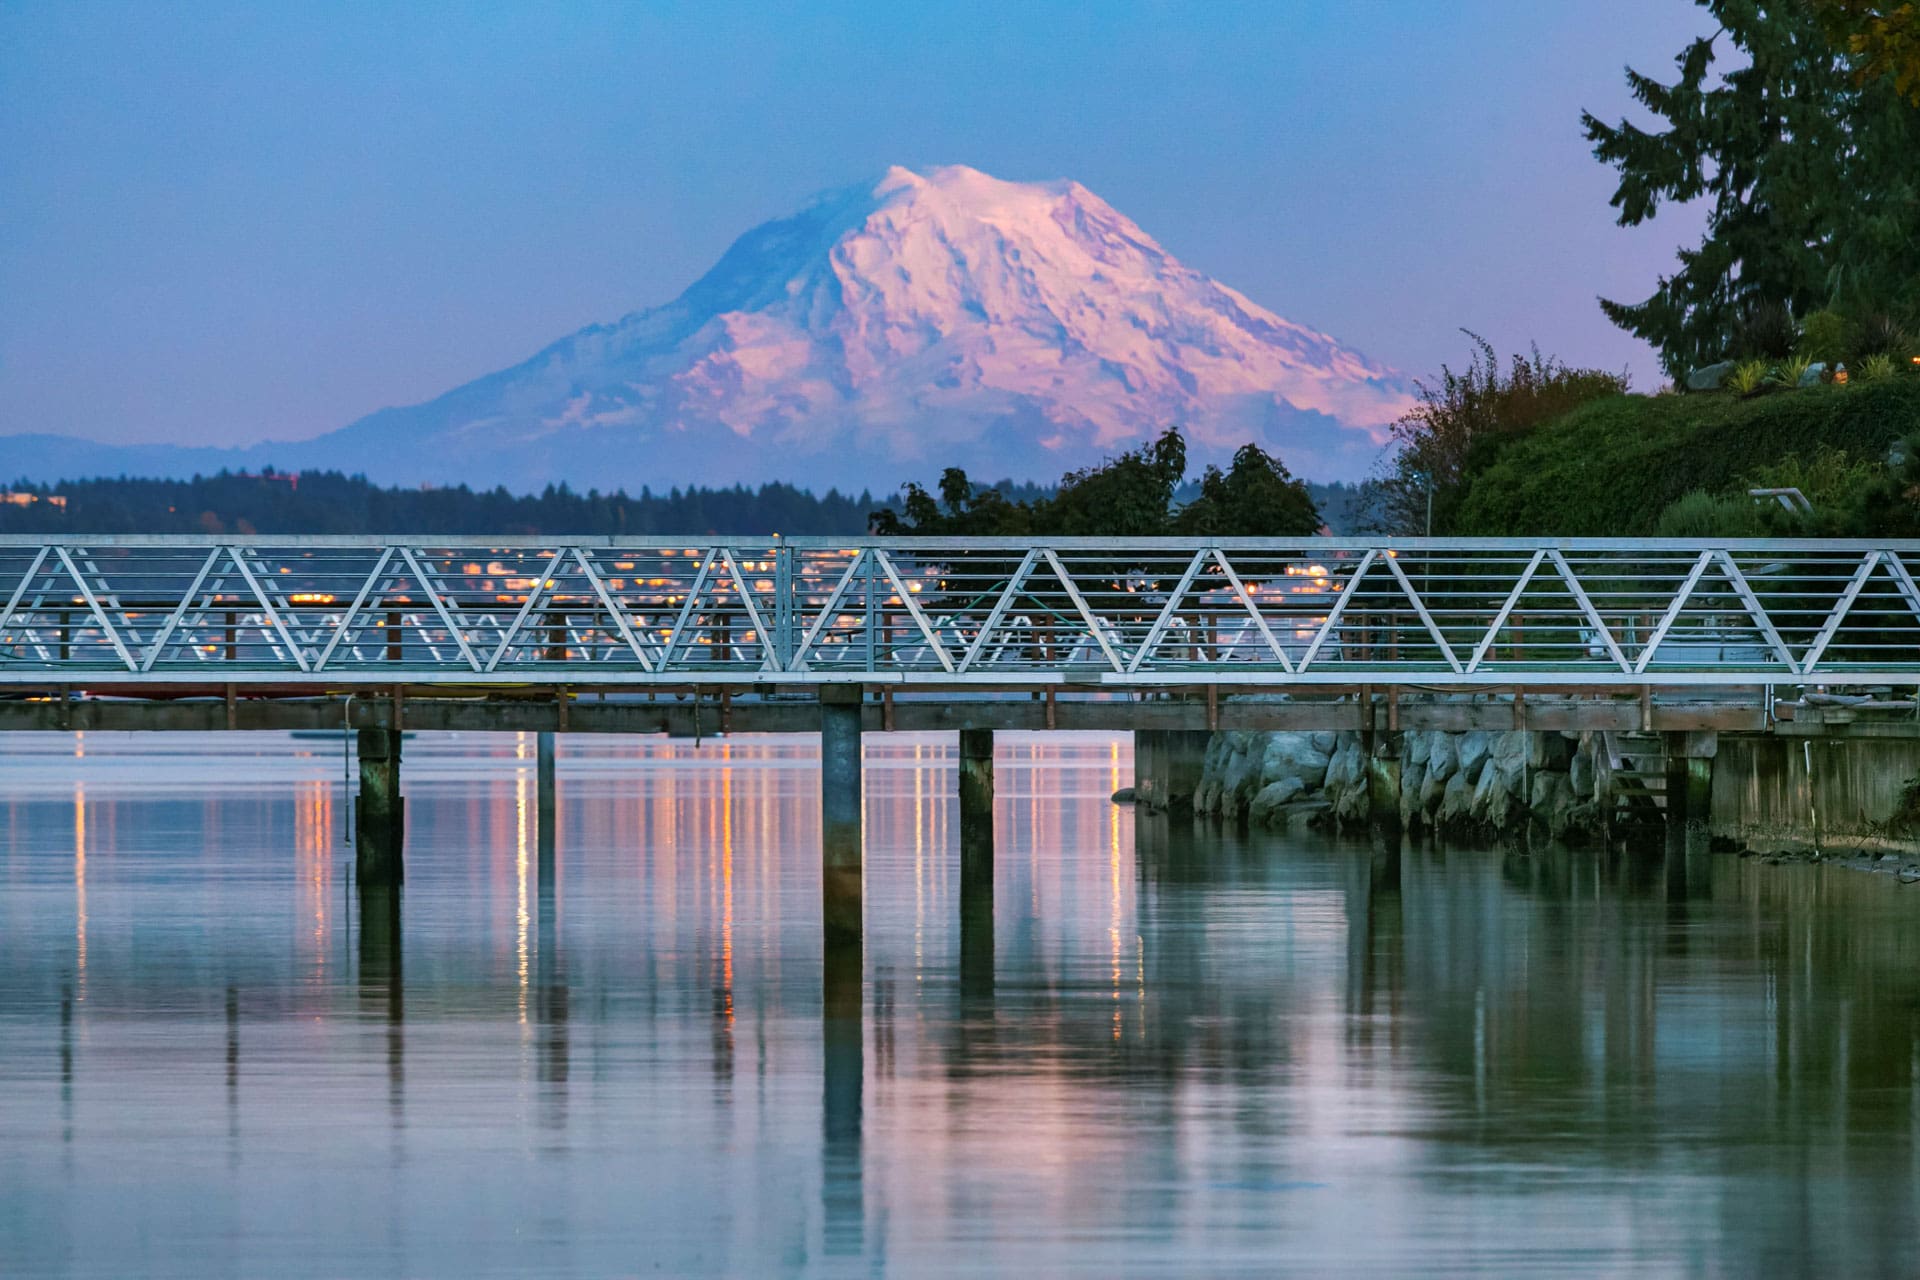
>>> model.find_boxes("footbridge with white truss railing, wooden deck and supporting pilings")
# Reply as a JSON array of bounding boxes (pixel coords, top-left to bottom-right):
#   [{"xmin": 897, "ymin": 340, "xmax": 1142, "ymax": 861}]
[{"xmin": 0, "ymin": 535, "xmax": 1920, "ymax": 936}]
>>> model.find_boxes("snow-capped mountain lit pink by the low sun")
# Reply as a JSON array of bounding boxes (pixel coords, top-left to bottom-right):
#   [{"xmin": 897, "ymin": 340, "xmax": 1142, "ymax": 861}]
[{"xmin": 0, "ymin": 167, "xmax": 1411, "ymax": 491}]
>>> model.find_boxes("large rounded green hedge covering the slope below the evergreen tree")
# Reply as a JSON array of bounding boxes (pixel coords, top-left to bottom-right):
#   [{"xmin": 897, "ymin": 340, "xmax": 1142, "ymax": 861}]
[{"xmin": 1450, "ymin": 378, "xmax": 1920, "ymax": 537}]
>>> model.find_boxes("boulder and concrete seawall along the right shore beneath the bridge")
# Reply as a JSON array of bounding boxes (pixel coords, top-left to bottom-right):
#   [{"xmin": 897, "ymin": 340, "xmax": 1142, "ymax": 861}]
[{"xmin": 1140, "ymin": 729, "xmax": 1920, "ymax": 854}]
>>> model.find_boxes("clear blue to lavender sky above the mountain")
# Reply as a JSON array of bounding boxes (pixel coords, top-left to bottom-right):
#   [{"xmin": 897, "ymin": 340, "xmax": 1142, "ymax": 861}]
[{"xmin": 0, "ymin": 0, "xmax": 1707, "ymax": 443}]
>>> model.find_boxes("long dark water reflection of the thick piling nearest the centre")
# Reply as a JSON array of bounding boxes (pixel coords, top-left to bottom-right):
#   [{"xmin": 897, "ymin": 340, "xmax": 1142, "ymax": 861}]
[{"xmin": 820, "ymin": 938, "xmax": 866, "ymax": 1255}]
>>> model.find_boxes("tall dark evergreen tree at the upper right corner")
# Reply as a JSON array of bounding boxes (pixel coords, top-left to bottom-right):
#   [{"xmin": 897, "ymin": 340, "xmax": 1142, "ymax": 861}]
[{"xmin": 1582, "ymin": 0, "xmax": 1920, "ymax": 378}]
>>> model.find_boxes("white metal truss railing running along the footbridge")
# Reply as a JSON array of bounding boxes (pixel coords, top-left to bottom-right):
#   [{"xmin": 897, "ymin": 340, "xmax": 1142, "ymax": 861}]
[{"xmin": 0, "ymin": 535, "xmax": 1920, "ymax": 687}]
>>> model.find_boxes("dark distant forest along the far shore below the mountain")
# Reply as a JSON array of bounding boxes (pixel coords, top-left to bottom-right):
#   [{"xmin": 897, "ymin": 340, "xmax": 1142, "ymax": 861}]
[{"xmin": 0, "ymin": 470, "xmax": 1357, "ymax": 535}]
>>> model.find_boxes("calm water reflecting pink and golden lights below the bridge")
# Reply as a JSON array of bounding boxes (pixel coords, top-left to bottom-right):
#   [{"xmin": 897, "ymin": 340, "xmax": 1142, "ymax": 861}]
[{"xmin": 0, "ymin": 735, "xmax": 1920, "ymax": 1276}]
